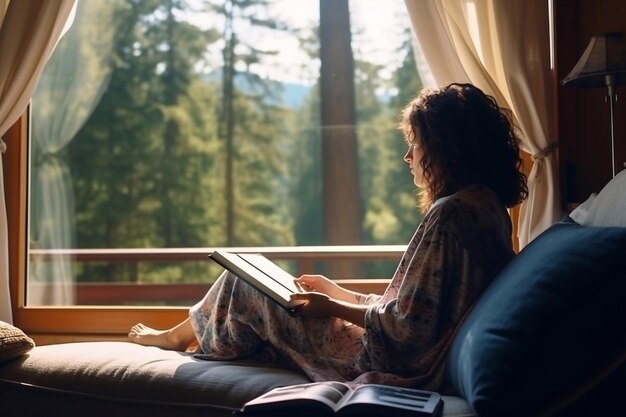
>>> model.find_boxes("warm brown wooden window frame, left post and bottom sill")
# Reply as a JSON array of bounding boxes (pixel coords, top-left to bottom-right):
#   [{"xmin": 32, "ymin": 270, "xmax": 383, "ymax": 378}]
[{"xmin": 3, "ymin": 112, "xmax": 388, "ymax": 345}]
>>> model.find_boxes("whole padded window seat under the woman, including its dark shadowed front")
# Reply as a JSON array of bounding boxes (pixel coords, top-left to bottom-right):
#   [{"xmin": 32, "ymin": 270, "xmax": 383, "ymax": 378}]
[{"xmin": 0, "ymin": 342, "xmax": 475, "ymax": 417}]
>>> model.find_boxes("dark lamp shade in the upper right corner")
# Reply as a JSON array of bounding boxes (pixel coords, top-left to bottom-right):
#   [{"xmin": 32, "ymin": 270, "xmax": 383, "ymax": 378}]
[{"xmin": 561, "ymin": 32, "xmax": 626, "ymax": 87}]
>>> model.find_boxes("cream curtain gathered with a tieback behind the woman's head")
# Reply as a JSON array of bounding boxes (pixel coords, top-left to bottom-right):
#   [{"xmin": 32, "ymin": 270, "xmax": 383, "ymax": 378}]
[{"xmin": 405, "ymin": 0, "xmax": 563, "ymax": 248}]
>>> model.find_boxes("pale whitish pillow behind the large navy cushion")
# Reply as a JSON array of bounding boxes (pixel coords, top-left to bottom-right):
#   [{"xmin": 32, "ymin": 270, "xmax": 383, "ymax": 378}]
[{"xmin": 570, "ymin": 169, "xmax": 626, "ymax": 227}]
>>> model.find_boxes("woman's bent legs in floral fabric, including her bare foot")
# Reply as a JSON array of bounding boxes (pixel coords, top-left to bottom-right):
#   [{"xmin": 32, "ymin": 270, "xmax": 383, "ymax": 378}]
[{"xmin": 129, "ymin": 273, "xmax": 363, "ymax": 380}]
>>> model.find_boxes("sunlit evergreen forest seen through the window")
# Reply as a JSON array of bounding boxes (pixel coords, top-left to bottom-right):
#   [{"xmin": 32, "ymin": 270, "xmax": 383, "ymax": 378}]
[{"xmin": 32, "ymin": 0, "xmax": 421, "ymax": 282}]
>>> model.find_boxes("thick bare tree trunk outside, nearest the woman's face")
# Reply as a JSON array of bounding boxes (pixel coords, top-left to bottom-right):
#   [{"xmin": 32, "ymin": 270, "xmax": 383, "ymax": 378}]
[{"xmin": 320, "ymin": 0, "xmax": 361, "ymax": 278}]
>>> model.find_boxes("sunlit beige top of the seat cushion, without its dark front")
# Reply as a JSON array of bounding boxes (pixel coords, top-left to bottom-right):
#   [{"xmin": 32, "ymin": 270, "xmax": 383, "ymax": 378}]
[{"xmin": 0, "ymin": 342, "xmax": 310, "ymax": 415}]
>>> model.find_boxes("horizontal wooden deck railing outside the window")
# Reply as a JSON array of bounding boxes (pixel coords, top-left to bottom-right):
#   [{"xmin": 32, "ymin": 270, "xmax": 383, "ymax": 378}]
[{"xmin": 29, "ymin": 245, "xmax": 405, "ymax": 305}]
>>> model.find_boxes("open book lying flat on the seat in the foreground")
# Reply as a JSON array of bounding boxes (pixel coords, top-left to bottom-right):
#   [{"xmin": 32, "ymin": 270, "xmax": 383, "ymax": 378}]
[{"xmin": 237, "ymin": 382, "xmax": 443, "ymax": 417}]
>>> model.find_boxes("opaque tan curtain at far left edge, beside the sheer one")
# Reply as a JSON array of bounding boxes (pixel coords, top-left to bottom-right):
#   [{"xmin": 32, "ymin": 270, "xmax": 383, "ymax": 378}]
[{"xmin": 0, "ymin": 0, "xmax": 75, "ymax": 323}]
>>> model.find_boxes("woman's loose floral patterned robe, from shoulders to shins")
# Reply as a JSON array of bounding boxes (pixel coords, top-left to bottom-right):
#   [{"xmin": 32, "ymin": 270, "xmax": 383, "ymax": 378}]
[{"xmin": 190, "ymin": 185, "xmax": 514, "ymax": 390}]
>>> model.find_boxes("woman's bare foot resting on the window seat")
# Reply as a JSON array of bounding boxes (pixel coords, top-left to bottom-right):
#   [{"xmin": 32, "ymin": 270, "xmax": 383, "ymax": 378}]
[{"xmin": 128, "ymin": 320, "xmax": 195, "ymax": 351}]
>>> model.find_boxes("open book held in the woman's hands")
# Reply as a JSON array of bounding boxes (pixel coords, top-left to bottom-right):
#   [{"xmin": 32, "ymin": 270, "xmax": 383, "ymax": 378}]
[{"xmin": 209, "ymin": 250, "xmax": 304, "ymax": 310}]
